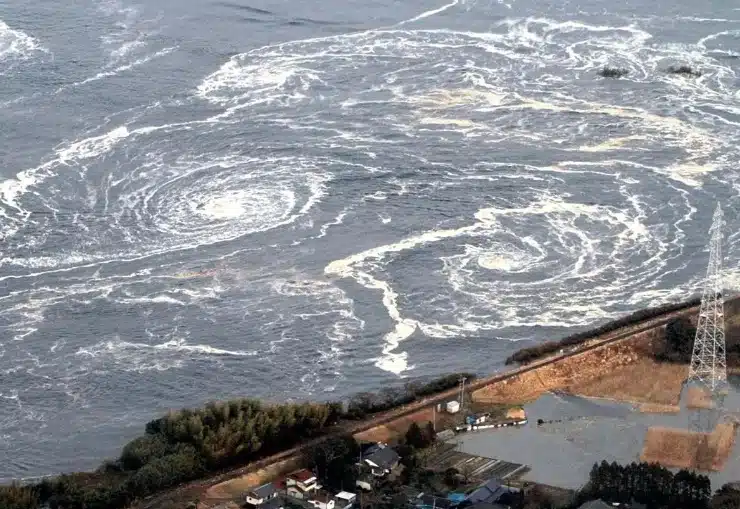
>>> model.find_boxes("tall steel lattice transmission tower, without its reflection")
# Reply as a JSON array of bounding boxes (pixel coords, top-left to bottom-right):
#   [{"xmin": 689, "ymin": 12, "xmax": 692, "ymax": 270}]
[{"xmin": 688, "ymin": 203, "xmax": 727, "ymax": 392}]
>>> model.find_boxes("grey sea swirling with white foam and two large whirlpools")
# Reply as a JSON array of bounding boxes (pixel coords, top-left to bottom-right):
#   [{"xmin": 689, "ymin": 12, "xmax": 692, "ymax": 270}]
[{"xmin": 0, "ymin": 0, "xmax": 740, "ymax": 478}]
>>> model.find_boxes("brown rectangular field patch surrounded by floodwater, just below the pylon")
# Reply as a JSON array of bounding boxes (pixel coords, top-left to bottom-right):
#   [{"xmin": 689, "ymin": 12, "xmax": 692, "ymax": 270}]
[{"xmin": 640, "ymin": 424, "xmax": 735, "ymax": 471}]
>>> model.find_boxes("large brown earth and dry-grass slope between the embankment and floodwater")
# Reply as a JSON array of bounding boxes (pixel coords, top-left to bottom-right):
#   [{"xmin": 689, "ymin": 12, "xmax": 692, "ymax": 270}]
[{"xmin": 473, "ymin": 329, "xmax": 687, "ymax": 405}]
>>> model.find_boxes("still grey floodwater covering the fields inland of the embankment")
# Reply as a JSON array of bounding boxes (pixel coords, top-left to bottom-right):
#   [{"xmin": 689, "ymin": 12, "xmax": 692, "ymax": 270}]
[{"xmin": 457, "ymin": 377, "xmax": 740, "ymax": 489}]
